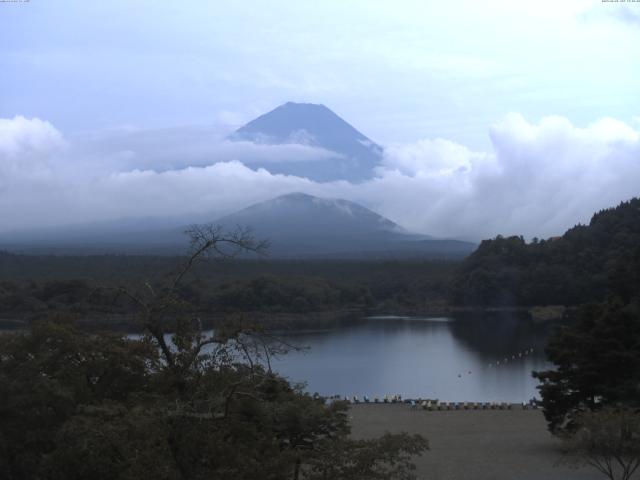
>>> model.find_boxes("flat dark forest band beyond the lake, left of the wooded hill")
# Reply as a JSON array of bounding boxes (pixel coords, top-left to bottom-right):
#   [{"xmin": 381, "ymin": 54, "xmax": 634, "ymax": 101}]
[{"xmin": 0, "ymin": 253, "xmax": 457, "ymax": 319}]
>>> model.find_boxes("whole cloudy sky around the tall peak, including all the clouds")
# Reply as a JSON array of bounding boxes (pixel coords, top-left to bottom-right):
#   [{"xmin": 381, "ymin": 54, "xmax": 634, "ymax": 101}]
[{"xmin": 0, "ymin": 0, "xmax": 640, "ymax": 238}]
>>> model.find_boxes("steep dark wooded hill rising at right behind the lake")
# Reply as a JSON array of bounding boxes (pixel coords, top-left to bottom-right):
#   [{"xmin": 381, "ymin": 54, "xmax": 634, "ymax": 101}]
[{"xmin": 450, "ymin": 198, "xmax": 640, "ymax": 306}]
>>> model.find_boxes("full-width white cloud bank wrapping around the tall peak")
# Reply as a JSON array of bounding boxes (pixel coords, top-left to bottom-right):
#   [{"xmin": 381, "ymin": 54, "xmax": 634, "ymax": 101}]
[{"xmin": 0, "ymin": 114, "xmax": 640, "ymax": 239}]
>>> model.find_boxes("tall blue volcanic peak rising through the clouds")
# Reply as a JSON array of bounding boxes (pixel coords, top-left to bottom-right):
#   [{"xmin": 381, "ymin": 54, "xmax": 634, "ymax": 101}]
[{"xmin": 229, "ymin": 102, "xmax": 382, "ymax": 182}]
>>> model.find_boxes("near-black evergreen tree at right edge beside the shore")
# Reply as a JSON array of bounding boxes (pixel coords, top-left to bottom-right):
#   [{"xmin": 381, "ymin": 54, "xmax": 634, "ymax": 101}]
[{"xmin": 534, "ymin": 301, "xmax": 640, "ymax": 433}]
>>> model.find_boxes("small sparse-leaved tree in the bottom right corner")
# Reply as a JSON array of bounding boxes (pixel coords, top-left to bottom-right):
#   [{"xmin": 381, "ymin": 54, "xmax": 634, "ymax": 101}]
[{"xmin": 567, "ymin": 407, "xmax": 640, "ymax": 480}]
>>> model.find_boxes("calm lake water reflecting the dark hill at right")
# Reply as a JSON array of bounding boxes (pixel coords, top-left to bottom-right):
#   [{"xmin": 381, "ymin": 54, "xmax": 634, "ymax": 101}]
[{"xmin": 272, "ymin": 316, "xmax": 550, "ymax": 402}]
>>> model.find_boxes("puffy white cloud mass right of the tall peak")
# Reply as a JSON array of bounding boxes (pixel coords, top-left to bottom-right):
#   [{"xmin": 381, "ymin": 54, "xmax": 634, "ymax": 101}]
[{"xmin": 369, "ymin": 114, "xmax": 640, "ymax": 238}]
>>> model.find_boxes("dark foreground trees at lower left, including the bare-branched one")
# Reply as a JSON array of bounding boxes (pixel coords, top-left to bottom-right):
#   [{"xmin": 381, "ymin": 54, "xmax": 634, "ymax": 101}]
[{"xmin": 0, "ymin": 227, "xmax": 427, "ymax": 480}]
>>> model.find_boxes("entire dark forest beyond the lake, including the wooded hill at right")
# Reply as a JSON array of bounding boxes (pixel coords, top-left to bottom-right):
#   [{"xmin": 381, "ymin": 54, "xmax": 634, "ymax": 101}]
[{"xmin": 5, "ymin": 198, "xmax": 640, "ymax": 319}]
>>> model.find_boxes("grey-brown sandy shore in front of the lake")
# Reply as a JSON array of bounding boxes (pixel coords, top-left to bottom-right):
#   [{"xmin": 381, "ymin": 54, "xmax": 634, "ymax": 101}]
[{"xmin": 350, "ymin": 404, "xmax": 602, "ymax": 480}]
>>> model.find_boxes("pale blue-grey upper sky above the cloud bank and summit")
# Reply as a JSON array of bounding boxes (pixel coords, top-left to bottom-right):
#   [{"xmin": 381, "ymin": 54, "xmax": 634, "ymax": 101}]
[{"xmin": 0, "ymin": 0, "xmax": 640, "ymax": 148}]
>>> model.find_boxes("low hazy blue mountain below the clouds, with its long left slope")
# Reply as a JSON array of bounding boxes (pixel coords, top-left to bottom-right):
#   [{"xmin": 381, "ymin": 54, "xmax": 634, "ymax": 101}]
[{"xmin": 0, "ymin": 193, "xmax": 475, "ymax": 259}]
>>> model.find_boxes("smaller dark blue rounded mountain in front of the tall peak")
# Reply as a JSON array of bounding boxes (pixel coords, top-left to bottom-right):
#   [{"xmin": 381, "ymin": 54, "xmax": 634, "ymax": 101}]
[{"xmin": 217, "ymin": 193, "xmax": 475, "ymax": 258}]
